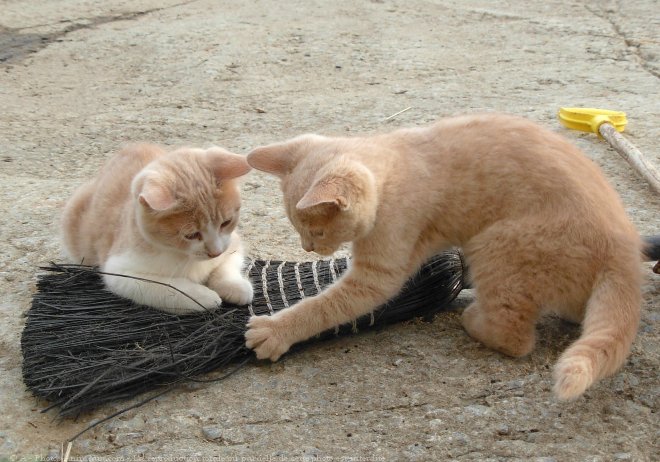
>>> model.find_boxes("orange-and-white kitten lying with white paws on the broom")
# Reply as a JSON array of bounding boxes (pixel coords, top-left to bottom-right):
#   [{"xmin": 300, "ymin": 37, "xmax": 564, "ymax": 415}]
[{"xmin": 62, "ymin": 144, "xmax": 252, "ymax": 314}]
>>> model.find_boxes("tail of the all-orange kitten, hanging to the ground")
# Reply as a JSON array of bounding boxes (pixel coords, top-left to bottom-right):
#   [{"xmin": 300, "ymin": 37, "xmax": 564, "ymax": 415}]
[{"xmin": 554, "ymin": 258, "xmax": 642, "ymax": 400}]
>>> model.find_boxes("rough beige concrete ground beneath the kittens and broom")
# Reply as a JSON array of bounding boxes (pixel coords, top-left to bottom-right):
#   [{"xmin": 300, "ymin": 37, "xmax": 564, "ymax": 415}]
[{"xmin": 0, "ymin": 0, "xmax": 660, "ymax": 461}]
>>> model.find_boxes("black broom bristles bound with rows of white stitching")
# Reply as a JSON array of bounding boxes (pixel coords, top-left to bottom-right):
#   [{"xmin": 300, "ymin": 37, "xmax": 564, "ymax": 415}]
[{"xmin": 21, "ymin": 250, "xmax": 464, "ymax": 416}]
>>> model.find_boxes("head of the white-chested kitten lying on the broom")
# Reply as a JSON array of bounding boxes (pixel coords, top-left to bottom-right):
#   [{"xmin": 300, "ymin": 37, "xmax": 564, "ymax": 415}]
[{"xmin": 132, "ymin": 147, "xmax": 250, "ymax": 259}]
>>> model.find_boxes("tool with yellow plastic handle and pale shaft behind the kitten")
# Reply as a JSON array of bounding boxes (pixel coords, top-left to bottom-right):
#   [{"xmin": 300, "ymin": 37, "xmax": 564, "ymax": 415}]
[{"xmin": 558, "ymin": 107, "xmax": 660, "ymax": 193}]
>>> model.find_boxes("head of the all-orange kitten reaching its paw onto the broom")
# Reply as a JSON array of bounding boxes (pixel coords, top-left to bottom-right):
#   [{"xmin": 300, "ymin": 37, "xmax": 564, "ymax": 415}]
[{"xmin": 247, "ymin": 135, "xmax": 377, "ymax": 255}]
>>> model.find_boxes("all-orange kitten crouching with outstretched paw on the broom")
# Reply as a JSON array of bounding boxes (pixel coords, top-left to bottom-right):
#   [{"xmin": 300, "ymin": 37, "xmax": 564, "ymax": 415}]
[{"xmin": 246, "ymin": 114, "xmax": 641, "ymax": 399}]
